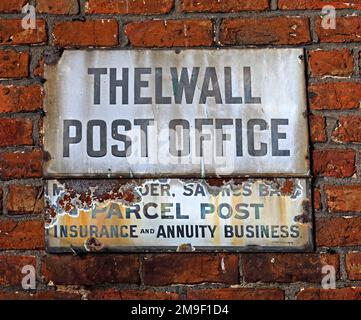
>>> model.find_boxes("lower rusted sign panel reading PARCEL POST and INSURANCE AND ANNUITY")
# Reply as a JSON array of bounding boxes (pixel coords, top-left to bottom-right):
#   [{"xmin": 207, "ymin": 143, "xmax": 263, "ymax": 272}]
[{"xmin": 45, "ymin": 178, "xmax": 312, "ymax": 252}]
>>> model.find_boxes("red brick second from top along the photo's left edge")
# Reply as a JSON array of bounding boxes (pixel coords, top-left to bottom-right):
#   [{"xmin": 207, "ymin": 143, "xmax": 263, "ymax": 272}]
[{"xmin": 0, "ymin": 19, "xmax": 47, "ymax": 45}]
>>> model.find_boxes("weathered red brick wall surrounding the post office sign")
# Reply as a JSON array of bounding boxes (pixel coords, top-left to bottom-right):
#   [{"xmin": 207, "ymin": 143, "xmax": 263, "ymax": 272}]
[{"xmin": 0, "ymin": 0, "xmax": 361, "ymax": 299}]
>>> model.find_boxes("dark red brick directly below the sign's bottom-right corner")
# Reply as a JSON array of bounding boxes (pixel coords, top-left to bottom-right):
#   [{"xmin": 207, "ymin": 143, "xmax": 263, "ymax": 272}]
[{"xmin": 241, "ymin": 253, "xmax": 339, "ymax": 282}]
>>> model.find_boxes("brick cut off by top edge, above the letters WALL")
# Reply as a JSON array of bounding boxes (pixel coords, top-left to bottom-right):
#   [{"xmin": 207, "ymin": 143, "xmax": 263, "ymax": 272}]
[{"xmin": 179, "ymin": 0, "xmax": 269, "ymax": 12}]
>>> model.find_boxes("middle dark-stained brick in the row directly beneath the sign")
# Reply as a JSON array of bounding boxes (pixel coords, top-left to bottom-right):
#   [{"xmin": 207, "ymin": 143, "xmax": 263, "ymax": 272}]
[{"xmin": 143, "ymin": 254, "xmax": 238, "ymax": 286}]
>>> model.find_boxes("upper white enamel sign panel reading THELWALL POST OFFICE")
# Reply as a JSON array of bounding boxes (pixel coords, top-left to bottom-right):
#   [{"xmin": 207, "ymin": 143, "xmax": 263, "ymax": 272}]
[{"xmin": 44, "ymin": 49, "xmax": 309, "ymax": 178}]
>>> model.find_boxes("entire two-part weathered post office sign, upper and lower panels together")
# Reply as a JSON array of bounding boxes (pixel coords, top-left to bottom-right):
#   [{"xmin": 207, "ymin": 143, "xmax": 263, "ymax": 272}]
[{"xmin": 44, "ymin": 49, "xmax": 313, "ymax": 252}]
